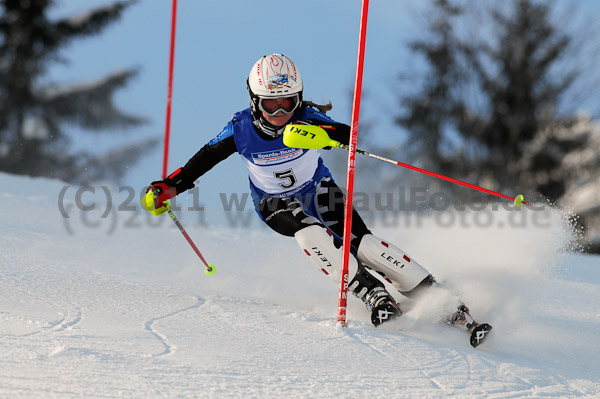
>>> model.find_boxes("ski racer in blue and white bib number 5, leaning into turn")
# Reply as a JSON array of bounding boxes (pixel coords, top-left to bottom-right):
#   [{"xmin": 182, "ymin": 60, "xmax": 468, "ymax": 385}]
[{"xmin": 146, "ymin": 54, "xmax": 468, "ymax": 326}]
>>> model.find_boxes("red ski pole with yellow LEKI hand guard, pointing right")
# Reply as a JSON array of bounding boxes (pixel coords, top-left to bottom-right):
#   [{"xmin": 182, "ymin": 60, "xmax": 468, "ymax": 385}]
[{"xmin": 283, "ymin": 124, "xmax": 530, "ymax": 208}]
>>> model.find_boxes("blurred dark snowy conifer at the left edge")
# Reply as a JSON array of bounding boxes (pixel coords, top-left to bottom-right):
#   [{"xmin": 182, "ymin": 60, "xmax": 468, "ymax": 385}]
[{"xmin": 0, "ymin": 0, "xmax": 157, "ymax": 184}]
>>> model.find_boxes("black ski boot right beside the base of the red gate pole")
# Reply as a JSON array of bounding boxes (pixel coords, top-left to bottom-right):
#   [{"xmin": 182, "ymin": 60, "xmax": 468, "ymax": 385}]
[{"xmin": 349, "ymin": 265, "xmax": 402, "ymax": 327}]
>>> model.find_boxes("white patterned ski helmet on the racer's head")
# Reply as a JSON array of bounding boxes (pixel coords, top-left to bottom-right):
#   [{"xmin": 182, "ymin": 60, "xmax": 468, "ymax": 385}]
[{"xmin": 247, "ymin": 54, "xmax": 303, "ymax": 119}]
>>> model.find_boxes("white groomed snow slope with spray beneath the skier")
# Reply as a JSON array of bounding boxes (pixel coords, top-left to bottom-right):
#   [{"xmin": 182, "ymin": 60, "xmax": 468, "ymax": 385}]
[{"xmin": 0, "ymin": 174, "xmax": 600, "ymax": 398}]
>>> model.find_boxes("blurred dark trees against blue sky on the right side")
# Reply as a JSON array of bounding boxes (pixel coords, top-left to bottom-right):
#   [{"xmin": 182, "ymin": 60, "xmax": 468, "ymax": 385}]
[{"xmin": 396, "ymin": 0, "xmax": 600, "ymax": 252}]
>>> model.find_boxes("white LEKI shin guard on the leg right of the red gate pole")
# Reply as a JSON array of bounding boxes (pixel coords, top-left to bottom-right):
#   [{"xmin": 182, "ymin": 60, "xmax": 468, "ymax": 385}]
[{"xmin": 358, "ymin": 234, "xmax": 430, "ymax": 294}]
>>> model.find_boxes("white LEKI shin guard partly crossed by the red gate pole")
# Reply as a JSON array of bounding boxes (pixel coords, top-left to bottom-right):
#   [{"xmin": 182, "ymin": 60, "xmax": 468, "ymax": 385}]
[{"xmin": 294, "ymin": 225, "xmax": 358, "ymax": 284}]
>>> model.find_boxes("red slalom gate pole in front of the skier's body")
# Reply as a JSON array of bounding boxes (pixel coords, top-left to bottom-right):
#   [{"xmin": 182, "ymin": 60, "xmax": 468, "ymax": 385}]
[{"xmin": 338, "ymin": 0, "xmax": 369, "ymax": 327}]
